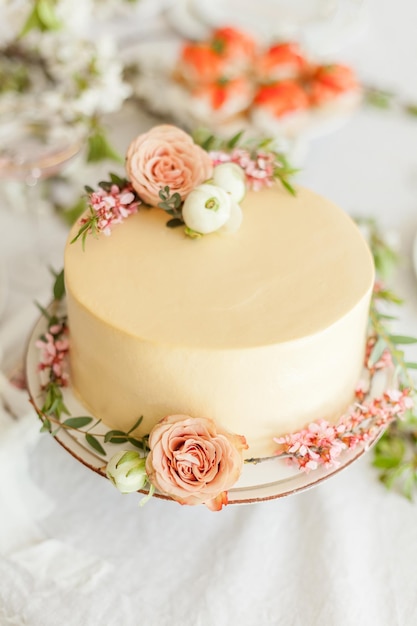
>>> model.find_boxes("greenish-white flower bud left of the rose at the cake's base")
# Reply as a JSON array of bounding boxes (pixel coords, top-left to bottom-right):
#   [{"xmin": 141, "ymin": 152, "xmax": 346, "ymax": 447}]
[{"xmin": 106, "ymin": 450, "xmax": 148, "ymax": 493}]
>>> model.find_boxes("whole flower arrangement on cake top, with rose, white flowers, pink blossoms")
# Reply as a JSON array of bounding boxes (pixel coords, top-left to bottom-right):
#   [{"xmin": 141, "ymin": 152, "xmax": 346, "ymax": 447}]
[{"xmin": 73, "ymin": 124, "xmax": 295, "ymax": 244}]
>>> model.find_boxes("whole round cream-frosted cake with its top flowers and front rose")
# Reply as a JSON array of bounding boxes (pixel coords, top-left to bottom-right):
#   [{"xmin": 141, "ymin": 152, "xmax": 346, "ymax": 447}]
[{"xmin": 58, "ymin": 126, "xmax": 374, "ymax": 508}]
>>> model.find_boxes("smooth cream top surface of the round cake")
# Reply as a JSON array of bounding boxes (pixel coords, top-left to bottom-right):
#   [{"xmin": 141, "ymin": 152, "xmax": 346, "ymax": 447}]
[{"xmin": 65, "ymin": 185, "xmax": 374, "ymax": 349}]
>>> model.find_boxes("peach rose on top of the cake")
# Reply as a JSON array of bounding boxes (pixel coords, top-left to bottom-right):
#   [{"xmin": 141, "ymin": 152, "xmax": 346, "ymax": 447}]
[{"xmin": 126, "ymin": 124, "xmax": 213, "ymax": 206}]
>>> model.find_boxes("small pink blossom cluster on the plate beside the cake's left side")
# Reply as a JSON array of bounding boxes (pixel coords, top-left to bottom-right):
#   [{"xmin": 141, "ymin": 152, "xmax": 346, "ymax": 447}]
[{"xmin": 35, "ymin": 323, "xmax": 69, "ymax": 387}]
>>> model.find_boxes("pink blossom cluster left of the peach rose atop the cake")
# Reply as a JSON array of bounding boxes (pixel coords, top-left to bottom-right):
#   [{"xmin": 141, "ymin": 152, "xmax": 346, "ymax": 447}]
[{"xmin": 81, "ymin": 184, "xmax": 140, "ymax": 236}]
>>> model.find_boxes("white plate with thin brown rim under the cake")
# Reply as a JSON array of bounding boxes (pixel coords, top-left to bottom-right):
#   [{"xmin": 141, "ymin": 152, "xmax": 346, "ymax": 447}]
[{"xmin": 26, "ymin": 308, "xmax": 392, "ymax": 504}]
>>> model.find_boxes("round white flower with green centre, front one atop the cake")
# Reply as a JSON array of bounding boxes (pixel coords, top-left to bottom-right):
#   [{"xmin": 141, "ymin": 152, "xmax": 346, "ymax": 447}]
[{"xmin": 182, "ymin": 183, "xmax": 232, "ymax": 235}]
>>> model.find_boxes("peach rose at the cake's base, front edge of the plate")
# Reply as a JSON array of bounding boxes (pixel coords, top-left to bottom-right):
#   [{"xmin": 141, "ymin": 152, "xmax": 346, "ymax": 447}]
[{"xmin": 146, "ymin": 415, "xmax": 248, "ymax": 511}]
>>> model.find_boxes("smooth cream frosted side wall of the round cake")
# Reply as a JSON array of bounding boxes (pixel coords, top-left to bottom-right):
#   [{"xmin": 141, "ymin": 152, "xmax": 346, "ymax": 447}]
[{"xmin": 68, "ymin": 286, "xmax": 370, "ymax": 456}]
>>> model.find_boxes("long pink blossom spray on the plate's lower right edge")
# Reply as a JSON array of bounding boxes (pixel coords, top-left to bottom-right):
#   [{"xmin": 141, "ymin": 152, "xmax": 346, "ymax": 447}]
[{"xmin": 274, "ymin": 389, "xmax": 413, "ymax": 472}]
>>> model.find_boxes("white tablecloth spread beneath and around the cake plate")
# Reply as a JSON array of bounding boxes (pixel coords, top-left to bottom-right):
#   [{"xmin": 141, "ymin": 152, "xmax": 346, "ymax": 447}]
[{"xmin": 0, "ymin": 0, "xmax": 417, "ymax": 626}]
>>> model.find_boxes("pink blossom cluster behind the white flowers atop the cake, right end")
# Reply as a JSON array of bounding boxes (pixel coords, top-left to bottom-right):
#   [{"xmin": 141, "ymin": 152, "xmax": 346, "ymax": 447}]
[{"xmin": 209, "ymin": 148, "xmax": 277, "ymax": 191}]
